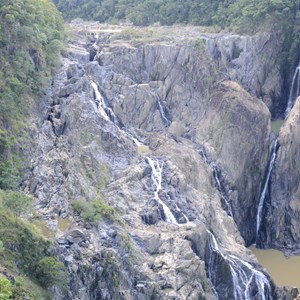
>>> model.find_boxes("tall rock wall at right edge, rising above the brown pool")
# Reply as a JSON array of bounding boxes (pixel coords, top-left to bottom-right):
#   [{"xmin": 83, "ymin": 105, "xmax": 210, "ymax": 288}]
[{"xmin": 262, "ymin": 98, "xmax": 300, "ymax": 253}]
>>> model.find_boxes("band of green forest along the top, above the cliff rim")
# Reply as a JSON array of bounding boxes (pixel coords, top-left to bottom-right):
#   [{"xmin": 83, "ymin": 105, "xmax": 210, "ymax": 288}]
[{"xmin": 54, "ymin": 0, "xmax": 300, "ymax": 71}]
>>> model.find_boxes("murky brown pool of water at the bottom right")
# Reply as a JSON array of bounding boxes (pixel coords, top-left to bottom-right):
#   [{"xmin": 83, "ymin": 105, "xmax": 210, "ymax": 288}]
[{"xmin": 250, "ymin": 246, "xmax": 300, "ymax": 290}]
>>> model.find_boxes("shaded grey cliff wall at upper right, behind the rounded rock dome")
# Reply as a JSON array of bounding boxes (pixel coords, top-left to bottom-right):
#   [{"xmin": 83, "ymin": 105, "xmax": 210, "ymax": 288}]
[{"xmin": 208, "ymin": 31, "xmax": 284, "ymax": 116}]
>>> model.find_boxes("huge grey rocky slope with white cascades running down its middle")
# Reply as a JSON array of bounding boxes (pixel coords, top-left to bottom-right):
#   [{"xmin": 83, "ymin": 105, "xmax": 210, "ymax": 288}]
[{"xmin": 24, "ymin": 24, "xmax": 298, "ymax": 300}]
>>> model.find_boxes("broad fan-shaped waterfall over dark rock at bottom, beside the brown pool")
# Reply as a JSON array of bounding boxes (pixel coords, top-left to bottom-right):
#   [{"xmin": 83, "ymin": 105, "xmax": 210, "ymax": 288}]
[{"xmin": 207, "ymin": 231, "xmax": 272, "ymax": 300}]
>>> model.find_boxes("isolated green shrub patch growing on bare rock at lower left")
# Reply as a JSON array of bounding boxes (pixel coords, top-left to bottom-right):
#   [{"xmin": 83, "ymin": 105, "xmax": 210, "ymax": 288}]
[{"xmin": 72, "ymin": 199, "xmax": 115, "ymax": 226}]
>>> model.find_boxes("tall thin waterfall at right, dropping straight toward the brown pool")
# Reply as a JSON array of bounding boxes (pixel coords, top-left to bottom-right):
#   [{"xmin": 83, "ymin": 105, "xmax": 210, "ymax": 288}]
[{"xmin": 256, "ymin": 138, "xmax": 279, "ymax": 240}]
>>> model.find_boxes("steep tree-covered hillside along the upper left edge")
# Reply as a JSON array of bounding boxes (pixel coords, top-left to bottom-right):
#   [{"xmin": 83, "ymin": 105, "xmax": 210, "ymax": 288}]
[{"xmin": 0, "ymin": 0, "xmax": 64, "ymax": 189}]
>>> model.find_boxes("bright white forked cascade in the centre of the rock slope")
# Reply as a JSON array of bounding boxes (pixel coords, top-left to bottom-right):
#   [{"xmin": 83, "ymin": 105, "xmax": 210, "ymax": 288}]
[{"xmin": 147, "ymin": 157, "xmax": 178, "ymax": 225}]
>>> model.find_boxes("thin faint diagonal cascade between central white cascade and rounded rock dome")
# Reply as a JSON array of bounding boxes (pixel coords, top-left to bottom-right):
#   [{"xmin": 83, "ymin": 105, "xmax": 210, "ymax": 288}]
[{"xmin": 198, "ymin": 149, "xmax": 233, "ymax": 218}]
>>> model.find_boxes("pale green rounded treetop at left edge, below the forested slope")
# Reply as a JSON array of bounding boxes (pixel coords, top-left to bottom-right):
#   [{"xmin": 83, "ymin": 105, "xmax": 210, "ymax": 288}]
[{"xmin": 3, "ymin": 191, "xmax": 33, "ymax": 218}]
